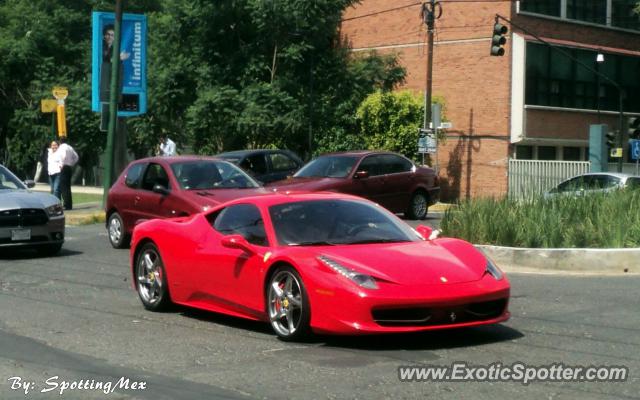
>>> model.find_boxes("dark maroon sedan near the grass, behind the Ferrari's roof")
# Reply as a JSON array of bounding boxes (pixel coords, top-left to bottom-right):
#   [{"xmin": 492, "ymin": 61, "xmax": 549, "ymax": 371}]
[{"xmin": 267, "ymin": 151, "xmax": 440, "ymax": 219}]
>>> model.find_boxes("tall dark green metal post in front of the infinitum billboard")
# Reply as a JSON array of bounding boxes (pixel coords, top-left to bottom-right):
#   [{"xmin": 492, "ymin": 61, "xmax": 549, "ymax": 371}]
[{"xmin": 102, "ymin": 0, "xmax": 124, "ymax": 205}]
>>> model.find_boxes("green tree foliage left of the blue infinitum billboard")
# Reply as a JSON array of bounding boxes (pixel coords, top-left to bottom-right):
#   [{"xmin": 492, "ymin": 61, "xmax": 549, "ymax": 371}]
[{"xmin": 0, "ymin": 0, "xmax": 158, "ymax": 178}]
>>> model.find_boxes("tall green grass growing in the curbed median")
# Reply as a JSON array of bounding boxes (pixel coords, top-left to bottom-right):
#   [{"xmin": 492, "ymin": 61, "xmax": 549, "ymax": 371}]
[{"xmin": 440, "ymin": 190, "xmax": 640, "ymax": 248}]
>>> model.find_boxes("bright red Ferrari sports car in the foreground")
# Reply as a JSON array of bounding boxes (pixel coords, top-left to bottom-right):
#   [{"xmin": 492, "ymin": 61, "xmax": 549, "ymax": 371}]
[{"xmin": 130, "ymin": 192, "xmax": 509, "ymax": 340}]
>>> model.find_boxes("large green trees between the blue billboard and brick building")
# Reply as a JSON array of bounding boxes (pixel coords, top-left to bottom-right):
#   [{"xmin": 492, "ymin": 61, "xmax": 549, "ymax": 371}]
[{"xmin": 131, "ymin": 0, "xmax": 404, "ymax": 156}]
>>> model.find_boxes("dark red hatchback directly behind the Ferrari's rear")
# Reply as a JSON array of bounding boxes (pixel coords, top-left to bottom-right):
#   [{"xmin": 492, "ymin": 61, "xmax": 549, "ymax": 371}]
[{"xmin": 105, "ymin": 156, "xmax": 267, "ymax": 248}]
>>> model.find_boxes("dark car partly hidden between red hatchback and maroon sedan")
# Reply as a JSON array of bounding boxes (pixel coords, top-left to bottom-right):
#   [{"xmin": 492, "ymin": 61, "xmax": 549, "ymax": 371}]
[{"xmin": 216, "ymin": 149, "xmax": 304, "ymax": 183}]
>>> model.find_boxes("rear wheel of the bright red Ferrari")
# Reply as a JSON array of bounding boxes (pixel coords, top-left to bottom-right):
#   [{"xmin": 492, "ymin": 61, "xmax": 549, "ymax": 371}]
[{"xmin": 135, "ymin": 243, "xmax": 171, "ymax": 311}]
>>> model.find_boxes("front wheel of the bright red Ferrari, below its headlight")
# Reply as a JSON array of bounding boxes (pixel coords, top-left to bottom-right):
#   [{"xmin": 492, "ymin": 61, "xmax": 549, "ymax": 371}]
[{"xmin": 267, "ymin": 266, "xmax": 311, "ymax": 341}]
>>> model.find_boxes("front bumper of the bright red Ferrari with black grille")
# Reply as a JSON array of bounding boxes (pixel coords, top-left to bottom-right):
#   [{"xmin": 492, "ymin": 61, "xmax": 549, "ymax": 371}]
[{"xmin": 309, "ymin": 276, "xmax": 510, "ymax": 334}]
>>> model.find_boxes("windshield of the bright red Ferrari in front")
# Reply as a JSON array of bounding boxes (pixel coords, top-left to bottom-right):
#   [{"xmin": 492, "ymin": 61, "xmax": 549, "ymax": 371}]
[{"xmin": 269, "ymin": 199, "xmax": 421, "ymax": 246}]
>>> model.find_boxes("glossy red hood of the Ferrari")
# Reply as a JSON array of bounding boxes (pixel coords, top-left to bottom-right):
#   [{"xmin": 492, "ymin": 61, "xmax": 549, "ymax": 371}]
[{"xmin": 320, "ymin": 239, "xmax": 486, "ymax": 285}]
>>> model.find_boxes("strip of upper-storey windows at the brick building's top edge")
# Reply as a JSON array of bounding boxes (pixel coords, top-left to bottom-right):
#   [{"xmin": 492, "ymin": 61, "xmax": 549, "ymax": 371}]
[{"xmin": 520, "ymin": 0, "xmax": 640, "ymax": 30}]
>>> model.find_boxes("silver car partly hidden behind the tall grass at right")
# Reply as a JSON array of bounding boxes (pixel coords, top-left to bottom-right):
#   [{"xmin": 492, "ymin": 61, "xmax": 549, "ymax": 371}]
[{"xmin": 545, "ymin": 172, "xmax": 640, "ymax": 198}]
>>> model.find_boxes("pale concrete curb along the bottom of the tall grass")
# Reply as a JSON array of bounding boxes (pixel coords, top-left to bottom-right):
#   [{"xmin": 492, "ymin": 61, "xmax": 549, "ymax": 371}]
[{"xmin": 476, "ymin": 245, "xmax": 640, "ymax": 274}]
